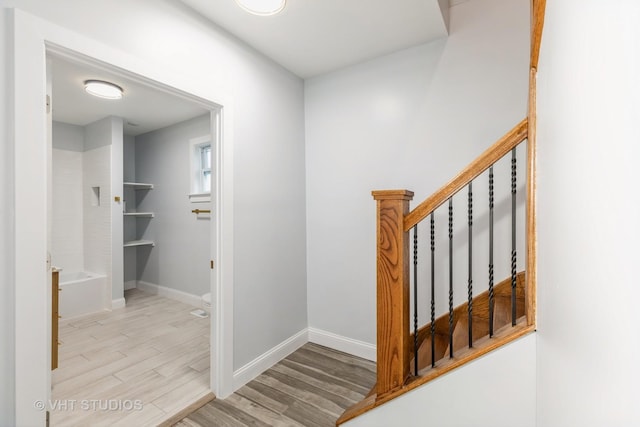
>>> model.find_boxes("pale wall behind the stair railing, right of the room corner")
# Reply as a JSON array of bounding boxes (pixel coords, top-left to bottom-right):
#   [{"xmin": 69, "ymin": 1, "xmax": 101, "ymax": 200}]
[{"xmin": 305, "ymin": 0, "xmax": 529, "ymax": 343}]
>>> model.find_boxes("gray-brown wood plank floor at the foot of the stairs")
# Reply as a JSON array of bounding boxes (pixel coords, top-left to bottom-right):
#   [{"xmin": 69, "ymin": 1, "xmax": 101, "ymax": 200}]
[{"xmin": 174, "ymin": 343, "xmax": 376, "ymax": 427}]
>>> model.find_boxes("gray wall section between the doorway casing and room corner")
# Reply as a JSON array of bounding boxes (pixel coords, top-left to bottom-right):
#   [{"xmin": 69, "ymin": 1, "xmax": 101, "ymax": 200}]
[{"xmin": 233, "ymin": 67, "xmax": 307, "ymax": 370}]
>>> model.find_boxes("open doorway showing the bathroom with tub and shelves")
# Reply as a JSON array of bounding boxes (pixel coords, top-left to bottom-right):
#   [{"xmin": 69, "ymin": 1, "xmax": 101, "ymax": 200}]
[{"xmin": 47, "ymin": 48, "xmax": 222, "ymax": 425}]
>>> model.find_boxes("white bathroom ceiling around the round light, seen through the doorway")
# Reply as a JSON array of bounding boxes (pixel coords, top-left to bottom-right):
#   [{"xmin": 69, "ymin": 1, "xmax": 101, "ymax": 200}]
[{"xmin": 50, "ymin": 56, "xmax": 207, "ymax": 136}]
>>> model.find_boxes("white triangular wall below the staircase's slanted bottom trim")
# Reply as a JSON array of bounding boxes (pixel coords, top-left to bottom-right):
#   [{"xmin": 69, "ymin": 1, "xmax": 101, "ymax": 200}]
[{"xmin": 344, "ymin": 334, "xmax": 536, "ymax": 427}]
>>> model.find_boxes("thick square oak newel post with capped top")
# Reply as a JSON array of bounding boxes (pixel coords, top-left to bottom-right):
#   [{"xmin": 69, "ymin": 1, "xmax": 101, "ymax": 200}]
[{"xmin": 372, "ymin": 190, "xmax": 413, "ymax": 397}]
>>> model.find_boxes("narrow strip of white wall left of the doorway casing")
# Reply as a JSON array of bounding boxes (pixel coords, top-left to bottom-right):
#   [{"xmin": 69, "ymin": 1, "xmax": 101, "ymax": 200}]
[{"xmin": 0, "ymin": 10, "xmax": 15, "ymax": 426}]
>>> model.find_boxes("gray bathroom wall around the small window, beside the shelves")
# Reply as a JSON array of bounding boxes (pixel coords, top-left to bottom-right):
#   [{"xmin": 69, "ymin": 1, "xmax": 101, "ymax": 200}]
[{"xmin": 136, "ymin": 113, "xmax": 215, "ymax": 296}]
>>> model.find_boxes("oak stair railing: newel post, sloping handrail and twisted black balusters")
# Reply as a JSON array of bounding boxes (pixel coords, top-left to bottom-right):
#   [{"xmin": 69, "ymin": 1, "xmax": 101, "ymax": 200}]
[{"xmin": 372, "ymin": 119, "xmax": 534, "ymax": 400}]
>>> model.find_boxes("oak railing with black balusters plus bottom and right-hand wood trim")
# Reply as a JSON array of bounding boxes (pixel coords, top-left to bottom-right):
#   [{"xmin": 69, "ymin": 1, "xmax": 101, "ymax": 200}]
[{"xmin": 336, "ymin": 0, "xmax": 546, "ymax": 425}]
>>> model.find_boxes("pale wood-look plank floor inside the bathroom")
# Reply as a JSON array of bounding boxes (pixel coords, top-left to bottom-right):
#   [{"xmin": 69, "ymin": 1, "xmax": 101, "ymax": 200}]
[{"xmin": 51, "ymin": 289, "xmax": 209, "ymax": 426}]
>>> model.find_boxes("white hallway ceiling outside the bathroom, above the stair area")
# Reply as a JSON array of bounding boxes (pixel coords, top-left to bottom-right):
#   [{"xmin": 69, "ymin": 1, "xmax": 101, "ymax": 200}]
[{"xmin": 181, "ymin": 0, "xmax": 452, "ymax": 78}]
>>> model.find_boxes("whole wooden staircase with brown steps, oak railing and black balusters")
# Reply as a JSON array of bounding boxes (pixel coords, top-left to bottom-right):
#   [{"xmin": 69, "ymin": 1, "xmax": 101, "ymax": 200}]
[{"xmin": 336, "ymin": 0, "xmax": 546, "ymax": 425}]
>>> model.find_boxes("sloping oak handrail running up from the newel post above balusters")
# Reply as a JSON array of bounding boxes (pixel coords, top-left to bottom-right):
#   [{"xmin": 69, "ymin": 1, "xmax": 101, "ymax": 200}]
[{"xmin": 404, "ymin": 119, "xmax": 527, "ymax": 231}]
